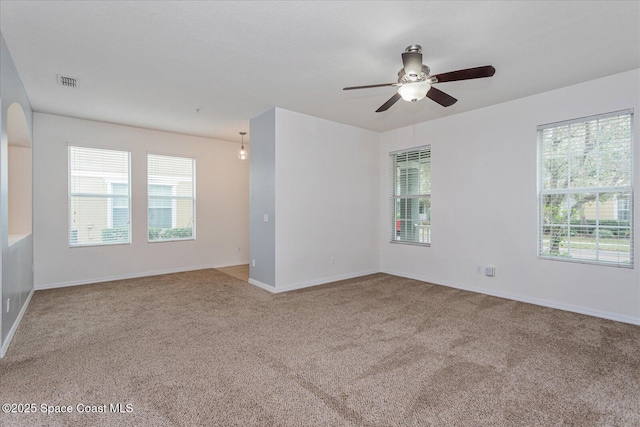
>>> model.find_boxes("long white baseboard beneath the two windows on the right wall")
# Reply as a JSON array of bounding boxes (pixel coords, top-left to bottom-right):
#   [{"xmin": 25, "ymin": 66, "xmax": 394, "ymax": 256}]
[{"xmin": 382, "ymin": 269, "xmax": 640, "ymax": 326}]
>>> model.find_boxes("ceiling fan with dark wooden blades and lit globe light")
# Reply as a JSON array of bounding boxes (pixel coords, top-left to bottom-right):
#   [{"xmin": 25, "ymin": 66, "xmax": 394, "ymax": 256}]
[{"xmin": 343, "ymin": 44, "xmax": 496, "ymax": 113}]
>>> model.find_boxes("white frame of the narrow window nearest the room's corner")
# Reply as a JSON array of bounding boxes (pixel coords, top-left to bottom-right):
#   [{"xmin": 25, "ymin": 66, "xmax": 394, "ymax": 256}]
[{"xmin": 389, "ymin": 144, "xmax": 432, "ymax": 247}]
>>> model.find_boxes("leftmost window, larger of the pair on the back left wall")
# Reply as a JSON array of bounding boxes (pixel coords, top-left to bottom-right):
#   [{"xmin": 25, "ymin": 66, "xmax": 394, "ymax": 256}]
[{"xmin": 68, "ymin": 146, "xmax": 131, "ymax": 247}]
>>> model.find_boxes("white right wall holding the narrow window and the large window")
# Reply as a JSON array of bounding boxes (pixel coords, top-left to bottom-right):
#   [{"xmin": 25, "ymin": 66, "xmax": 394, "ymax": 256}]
[{"xmin": 379, "ymin": 70, "xmax": 640, "ymax": 323}]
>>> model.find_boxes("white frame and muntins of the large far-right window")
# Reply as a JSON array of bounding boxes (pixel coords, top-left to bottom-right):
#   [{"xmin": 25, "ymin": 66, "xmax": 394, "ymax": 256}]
[{"xmin": 536, "ymin": 108, "xmax": 635, "ymax": 268}]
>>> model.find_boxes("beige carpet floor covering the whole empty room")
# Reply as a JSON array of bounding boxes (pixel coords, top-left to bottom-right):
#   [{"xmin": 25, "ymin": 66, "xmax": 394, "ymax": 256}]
[{"xmin": 0, "ymin": 270, "xmax": 640, "ymax": 427}]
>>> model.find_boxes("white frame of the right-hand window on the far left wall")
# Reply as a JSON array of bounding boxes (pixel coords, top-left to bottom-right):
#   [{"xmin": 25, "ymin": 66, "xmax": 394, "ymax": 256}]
[{"xmin": 146, "ymin": 152, "xmax": 197, "ymax": 243}]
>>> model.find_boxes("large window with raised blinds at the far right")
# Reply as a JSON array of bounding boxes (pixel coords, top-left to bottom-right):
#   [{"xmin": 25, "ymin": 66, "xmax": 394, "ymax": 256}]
[{"xmin": 538, "ymin": 110, "xmax": 633, "ymax": 267}]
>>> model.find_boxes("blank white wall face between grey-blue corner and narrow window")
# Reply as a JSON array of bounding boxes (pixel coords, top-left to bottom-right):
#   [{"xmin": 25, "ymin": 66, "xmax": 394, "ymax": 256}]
[{"xmin": 275, "ymin": 108, "xmax": 380, "ymax": 290}]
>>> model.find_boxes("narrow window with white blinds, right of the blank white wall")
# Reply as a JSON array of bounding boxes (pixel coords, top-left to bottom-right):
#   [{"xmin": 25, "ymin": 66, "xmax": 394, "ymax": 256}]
[{"xmin": 390, "ymin": 146, "xmax": 431, "ymax": 245}]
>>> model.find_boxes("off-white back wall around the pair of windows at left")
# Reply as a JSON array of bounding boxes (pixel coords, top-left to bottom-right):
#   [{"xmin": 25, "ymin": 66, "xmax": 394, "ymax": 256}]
[{"xmin": 33, "ymin": 113, "xmax": 249, "ymax": 289}]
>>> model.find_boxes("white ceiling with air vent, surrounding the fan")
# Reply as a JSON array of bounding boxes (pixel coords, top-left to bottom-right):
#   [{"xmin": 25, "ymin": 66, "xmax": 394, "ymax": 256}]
[{"xmin": 0, "ymin": 0, "xmax": 640, "ymax": 145}]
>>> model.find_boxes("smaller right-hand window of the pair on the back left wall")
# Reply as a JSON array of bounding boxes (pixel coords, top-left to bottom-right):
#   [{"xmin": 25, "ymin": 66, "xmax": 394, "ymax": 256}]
[{"xmin": 147, "ymin": 154, "xmax": 195, "ymax": 242}]
